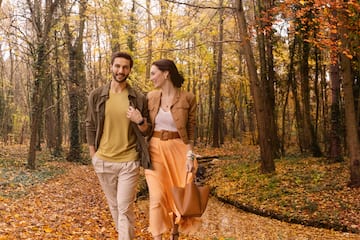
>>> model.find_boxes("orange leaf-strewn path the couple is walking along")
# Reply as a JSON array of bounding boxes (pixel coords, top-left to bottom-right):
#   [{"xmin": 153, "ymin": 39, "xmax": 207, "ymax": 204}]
[{"xmin": 0, "ymin": 164, "xmax": 360, "ymax": 240}]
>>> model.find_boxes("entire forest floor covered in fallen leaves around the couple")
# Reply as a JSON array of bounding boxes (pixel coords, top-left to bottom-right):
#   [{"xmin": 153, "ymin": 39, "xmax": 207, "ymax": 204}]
[{"xmin": 0, "ymin": 144, "xmax": 360, "ymax": 240}]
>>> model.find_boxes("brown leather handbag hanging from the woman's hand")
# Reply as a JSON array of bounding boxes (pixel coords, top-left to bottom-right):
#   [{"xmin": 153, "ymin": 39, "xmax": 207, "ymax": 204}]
[{"xmin": 171, "ymin": 173, "xmax": 210, "ymax": 217}]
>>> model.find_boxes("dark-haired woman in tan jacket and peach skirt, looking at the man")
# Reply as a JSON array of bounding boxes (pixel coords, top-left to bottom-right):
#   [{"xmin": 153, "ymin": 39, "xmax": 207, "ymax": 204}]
[{"xmin": 145, "ymin": 59, "xmax": 200, "ymax": 240}]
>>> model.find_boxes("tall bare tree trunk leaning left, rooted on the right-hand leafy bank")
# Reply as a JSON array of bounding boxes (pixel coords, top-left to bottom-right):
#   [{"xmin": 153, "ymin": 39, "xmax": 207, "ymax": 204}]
[{"xmin": 235, "ymin": 0, "xmax": 275, "ymax": 173}]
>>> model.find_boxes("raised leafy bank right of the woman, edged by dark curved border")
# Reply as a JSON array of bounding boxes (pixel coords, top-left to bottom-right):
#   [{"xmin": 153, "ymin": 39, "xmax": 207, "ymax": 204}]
[{"xmin": 194, "ymin": 142, "xmax": 360, "ymax": 234}]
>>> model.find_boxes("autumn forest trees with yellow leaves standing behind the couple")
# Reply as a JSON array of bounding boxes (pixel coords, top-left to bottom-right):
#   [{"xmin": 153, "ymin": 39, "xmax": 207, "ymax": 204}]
[{"xmin": 0, "ymin": 0, "xmax": 360, "ymax": 187}]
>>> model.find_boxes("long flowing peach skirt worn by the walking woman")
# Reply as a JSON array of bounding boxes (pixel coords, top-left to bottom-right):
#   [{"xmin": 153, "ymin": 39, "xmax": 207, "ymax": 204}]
[{"xmin": 145, "ymin": 137, "xmax": 201, "ymax": 236}]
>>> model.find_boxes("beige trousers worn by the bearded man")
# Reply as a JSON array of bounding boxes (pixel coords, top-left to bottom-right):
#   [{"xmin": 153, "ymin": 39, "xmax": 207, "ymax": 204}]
[{"xmin": 92, "ymin": 155, "xmax": 140, "ymax": 240}]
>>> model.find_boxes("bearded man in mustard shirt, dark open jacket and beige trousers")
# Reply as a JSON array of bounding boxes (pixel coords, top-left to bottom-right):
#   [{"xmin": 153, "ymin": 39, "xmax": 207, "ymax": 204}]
[{"xmin": 86, "ymin": 52, "xmax": 151, "ymax": 240}]
